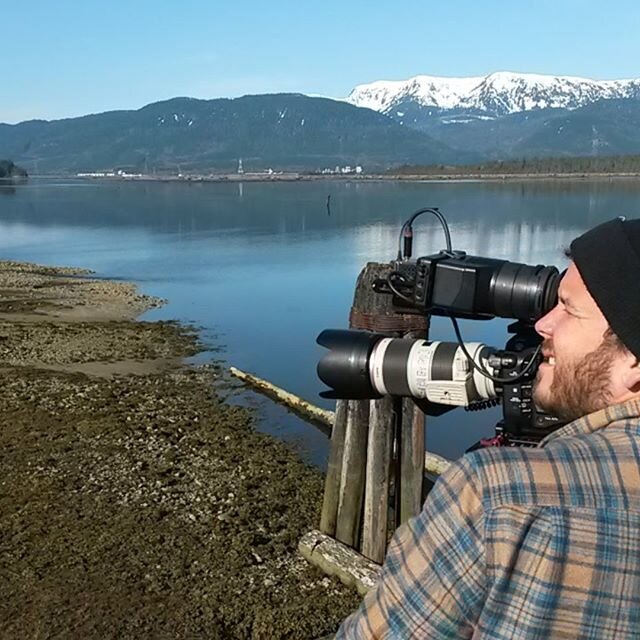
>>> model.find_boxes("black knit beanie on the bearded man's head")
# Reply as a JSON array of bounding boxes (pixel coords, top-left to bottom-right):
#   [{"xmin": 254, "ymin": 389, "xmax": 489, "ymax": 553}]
[{"xmin": 571, "ymin": 218, "xmax": 640, "ymax": 358}]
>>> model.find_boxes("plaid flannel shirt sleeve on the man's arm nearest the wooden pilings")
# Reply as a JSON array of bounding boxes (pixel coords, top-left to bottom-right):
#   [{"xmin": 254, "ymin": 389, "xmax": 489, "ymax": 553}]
[{"xmin": 336, "ymin": 454, "xmax": 486, "ymax": 640}]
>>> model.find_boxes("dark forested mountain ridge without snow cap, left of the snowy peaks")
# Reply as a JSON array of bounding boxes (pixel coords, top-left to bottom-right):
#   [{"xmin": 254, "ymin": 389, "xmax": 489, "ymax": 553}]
[{"xmin": 0, "ymin": 93, "xmax": 464, "ymax": 173}]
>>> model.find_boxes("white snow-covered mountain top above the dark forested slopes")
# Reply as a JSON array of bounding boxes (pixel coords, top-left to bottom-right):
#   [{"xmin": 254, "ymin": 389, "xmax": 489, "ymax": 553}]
[{"xmin": 346, "ymin": 71, "xmax": 640, "ymax": 119}]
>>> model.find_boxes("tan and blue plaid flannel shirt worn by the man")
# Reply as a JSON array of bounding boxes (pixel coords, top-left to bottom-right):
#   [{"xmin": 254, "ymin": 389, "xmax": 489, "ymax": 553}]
[{"xmin": 336, "ymin": 400, "xmax": 640, "ymax": 640}]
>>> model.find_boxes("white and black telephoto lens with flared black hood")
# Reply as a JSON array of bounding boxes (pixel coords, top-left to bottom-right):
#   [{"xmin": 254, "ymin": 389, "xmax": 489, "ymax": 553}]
[{"xmin": 317, "ymin": 329, "xmax": 498, "ymax": 407}]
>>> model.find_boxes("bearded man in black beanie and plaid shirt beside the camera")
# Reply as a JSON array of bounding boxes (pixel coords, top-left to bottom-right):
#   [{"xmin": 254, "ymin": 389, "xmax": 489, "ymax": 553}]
[{"xmin": 337, "ymin": 219, "xmax": 640, "ymax": 640}]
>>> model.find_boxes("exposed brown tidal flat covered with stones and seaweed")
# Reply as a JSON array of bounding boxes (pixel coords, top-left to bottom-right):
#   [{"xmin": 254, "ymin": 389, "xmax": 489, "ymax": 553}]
[{"xmin": 0, "ymin": 262, "xmax": 359, "ymax": 639}]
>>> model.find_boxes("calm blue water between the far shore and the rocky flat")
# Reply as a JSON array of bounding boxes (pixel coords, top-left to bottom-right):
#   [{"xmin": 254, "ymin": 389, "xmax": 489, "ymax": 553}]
[{"xmin": 0, "ymin": 181, "xmax": 640, "ymax": 464}]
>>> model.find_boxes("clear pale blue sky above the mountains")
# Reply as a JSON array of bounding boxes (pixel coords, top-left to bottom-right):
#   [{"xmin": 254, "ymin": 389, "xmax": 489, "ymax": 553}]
[{"xmin": 5, "ymin": 0, "xmax": 640, "ymax": 123}]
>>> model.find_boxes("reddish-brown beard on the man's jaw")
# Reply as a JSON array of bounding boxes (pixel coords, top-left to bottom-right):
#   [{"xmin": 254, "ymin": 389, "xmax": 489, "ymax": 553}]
[{"xmin": 533, "ymin": 335, "xmax": 619, "ymax": 420}]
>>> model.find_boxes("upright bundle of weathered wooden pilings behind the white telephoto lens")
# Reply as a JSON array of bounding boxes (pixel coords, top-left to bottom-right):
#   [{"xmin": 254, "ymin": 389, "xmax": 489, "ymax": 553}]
[{"xmin": 320, "ymin": 263, "xmax": 427, "ymax": 563}]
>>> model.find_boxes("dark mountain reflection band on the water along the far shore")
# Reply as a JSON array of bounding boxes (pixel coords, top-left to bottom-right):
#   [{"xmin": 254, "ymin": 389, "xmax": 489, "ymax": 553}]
[{"xmin": 0, "ymin": 180, "xmax": 639, "ymax": 233}]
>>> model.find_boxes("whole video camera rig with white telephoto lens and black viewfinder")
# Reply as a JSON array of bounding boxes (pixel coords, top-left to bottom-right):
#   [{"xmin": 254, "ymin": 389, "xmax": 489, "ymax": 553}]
[{"xmin": 317, "ymin": 208, "xmax": 562, "ymax": 446}]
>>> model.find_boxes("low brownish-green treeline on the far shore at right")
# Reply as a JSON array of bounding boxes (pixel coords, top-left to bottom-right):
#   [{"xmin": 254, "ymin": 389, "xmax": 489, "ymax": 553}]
[{"xmin": 387, "ymin": 155, "xmax": 640, "ymax": 175}]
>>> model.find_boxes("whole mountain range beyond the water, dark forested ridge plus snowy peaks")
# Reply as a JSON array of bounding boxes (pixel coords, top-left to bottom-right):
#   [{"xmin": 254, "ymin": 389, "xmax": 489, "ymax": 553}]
[{"xmin": 0, "ymin": 72, "xmax": 640, "ymax": 174}]
